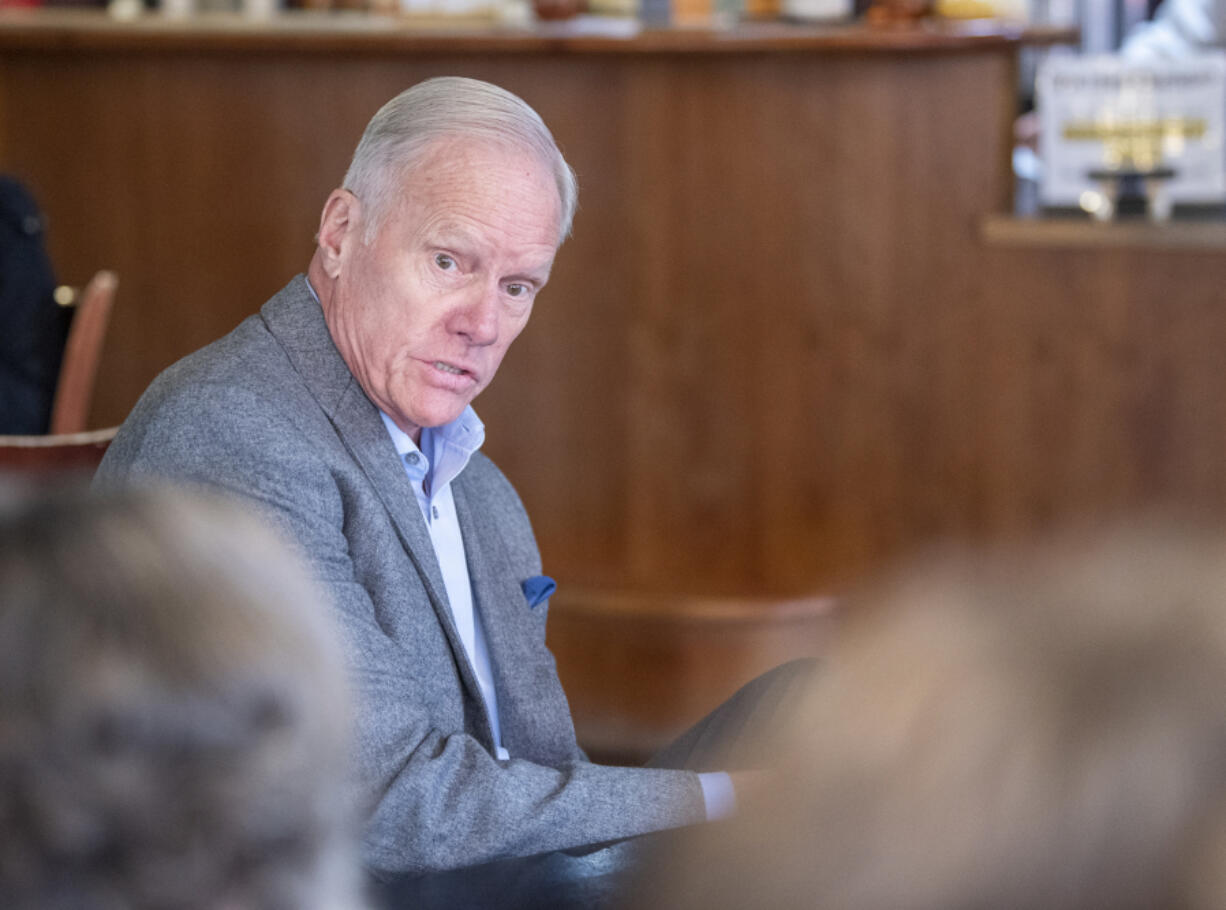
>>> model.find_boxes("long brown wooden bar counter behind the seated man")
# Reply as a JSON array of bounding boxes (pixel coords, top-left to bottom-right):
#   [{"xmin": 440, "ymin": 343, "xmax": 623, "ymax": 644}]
[{"xmin": 23, "ymin": 12, "xmax": 1211, "ymax": 755}]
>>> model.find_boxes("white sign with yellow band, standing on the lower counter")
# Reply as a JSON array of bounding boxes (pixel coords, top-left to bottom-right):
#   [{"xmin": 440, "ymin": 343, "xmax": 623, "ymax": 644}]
[{"xmin": 1035, "ymin": 52, "xmax": 1226, "ymax": 206}]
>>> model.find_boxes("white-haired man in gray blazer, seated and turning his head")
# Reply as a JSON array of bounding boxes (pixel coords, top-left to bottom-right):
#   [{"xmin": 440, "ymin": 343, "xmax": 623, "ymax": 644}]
[{"xmin": 98, "ymin": 78, "xmax": 799, "ymax": 872}]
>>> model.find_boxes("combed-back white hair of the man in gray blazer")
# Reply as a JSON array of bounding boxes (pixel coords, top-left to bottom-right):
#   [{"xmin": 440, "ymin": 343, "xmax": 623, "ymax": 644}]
[{"xmin": 343, "ymin": 76, "xmax": 579, "ymax": 243}]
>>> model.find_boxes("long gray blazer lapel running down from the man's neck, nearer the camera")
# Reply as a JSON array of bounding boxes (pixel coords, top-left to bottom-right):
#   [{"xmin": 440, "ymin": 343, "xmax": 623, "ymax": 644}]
[{"xmin": 261, "ymin": 276, "xmax": 484, "ymax": 716}]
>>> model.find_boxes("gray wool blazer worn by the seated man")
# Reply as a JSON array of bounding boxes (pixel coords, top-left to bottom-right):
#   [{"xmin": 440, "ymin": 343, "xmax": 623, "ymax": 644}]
[{"xmin": 96, "ymin": 276, "xmax": 704, "ymax": 872}]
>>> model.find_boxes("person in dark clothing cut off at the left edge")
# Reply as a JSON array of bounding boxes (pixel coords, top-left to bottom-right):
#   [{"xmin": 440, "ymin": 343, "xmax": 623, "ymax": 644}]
[{"xmin": 0, "ymin": 175, "xmax": 72, "ymax": 434}]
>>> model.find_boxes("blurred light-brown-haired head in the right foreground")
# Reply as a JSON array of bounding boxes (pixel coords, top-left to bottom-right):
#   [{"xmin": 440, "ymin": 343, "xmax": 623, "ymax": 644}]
[{"xmin": 634, "ymin": 527, "xmax": 1226, "ymax": 910}]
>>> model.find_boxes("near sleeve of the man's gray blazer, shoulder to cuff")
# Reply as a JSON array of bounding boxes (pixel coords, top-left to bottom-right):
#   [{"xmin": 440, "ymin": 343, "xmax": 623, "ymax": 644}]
[{"xmin": 97, "ymin": 388, "xmax": 705, "ymax": 873}]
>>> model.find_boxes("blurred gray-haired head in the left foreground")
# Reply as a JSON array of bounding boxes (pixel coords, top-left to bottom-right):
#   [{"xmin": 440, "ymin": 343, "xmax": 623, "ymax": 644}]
[{"xmin": 0, "ymin": 492, "xmax": 364, "ymax": 910}]
